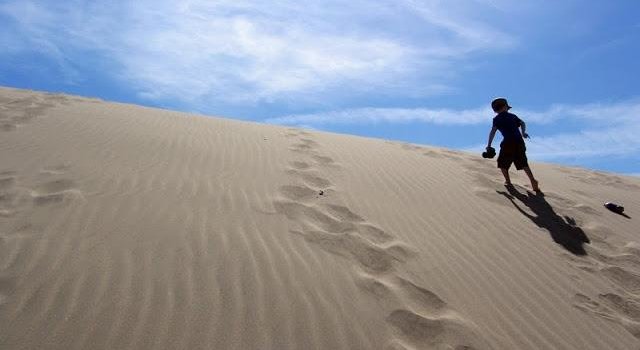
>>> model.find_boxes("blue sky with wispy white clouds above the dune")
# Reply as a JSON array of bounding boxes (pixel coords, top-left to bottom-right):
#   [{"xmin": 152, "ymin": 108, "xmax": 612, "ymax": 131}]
[{"xmin": 0, "ymin": 0, "xmax": 640, "ymax": 176}]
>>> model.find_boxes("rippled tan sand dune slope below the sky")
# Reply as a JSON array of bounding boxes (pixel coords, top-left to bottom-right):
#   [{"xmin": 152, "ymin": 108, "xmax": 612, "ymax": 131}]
[{"xmin": 0, "ymin": 88, "xmax": 640, "ymax": 350}]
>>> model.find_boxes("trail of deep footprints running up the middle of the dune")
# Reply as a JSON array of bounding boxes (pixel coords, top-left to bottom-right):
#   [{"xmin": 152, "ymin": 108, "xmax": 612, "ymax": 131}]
[{"xmin": 273, "ymin": 129, "xmax": 487, "ymax": 349}]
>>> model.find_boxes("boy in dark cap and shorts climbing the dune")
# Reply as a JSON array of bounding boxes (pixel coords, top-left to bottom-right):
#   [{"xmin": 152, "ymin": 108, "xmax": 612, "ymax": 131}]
[{"xmin": 487, "ymin": 98, "xmax": 540, "ymax": 192}]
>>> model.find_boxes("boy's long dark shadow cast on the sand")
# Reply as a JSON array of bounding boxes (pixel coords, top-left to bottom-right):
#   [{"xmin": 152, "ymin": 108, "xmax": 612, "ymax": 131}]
[{"xmin": 496, "ymin": 186, "xmax": 591, "ymax": 255}]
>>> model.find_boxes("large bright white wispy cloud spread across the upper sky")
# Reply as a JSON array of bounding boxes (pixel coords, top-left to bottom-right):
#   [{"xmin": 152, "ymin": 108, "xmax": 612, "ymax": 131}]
[{"xmin": 0, "ymin": 0, "xmax": 513, "ymax": 103}]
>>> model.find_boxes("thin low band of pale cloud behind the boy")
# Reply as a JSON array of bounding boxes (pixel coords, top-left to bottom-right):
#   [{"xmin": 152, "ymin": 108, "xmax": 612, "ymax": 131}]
[{"xmin": 266, "ymin": 100, "xmax": 640, "ymax": 161}]
